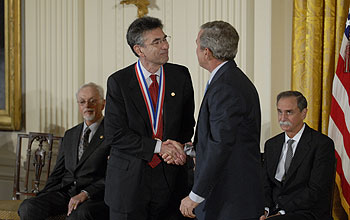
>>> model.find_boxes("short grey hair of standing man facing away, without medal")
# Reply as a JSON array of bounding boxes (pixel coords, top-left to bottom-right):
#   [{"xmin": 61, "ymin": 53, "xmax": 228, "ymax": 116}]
[{"xmin": 199, "ymin": 21, "xmax": 239, "ymax": 61}]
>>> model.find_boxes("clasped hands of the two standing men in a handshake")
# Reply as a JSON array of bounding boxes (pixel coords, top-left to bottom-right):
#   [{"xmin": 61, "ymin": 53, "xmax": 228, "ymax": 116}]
[{"xmin": 159, "ymin": 140, "xmax": 186, "ymax": 165}]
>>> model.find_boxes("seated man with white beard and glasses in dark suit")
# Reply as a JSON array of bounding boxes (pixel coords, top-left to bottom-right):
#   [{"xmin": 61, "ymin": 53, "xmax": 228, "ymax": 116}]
[{"xmin": 18, "ymin": 83, "xmax": 110, "ymax": 220}]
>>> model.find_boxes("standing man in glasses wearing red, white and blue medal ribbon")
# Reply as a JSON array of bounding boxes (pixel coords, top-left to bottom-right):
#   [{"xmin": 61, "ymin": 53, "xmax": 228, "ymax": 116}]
[{"xmin": 105, "ymin": 17, "xmax": 195, "ymax": 220}]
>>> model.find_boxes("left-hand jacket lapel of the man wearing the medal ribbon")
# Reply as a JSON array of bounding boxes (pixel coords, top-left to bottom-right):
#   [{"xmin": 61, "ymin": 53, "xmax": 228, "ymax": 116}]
[{"xmin": 129, "ymin": 65, "xmax": 153, "ymax": 135}]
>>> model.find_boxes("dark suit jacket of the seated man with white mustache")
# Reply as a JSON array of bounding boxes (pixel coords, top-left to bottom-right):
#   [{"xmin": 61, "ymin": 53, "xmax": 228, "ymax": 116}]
[{"xmin": 264, "ymin": 124, "xmax": 335, "ymax": 220}]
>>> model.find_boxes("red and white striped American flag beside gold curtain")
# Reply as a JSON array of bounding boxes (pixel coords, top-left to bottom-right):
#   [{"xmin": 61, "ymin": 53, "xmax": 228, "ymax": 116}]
[{"xmin": 328, "ymin": 9, "xmax": 350, "ymax": 218}]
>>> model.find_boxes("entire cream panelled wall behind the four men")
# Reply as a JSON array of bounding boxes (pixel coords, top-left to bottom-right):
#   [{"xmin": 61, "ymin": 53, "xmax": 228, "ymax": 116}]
[{"xmin": 0, "ymin": 0, "xmax": 292, "ymax": 199}]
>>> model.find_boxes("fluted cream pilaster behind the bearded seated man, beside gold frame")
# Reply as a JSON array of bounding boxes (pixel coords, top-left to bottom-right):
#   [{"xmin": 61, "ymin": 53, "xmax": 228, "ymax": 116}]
[{"xmin": 24, "ymin": 0, "xmax": 84, "ymax": 135}]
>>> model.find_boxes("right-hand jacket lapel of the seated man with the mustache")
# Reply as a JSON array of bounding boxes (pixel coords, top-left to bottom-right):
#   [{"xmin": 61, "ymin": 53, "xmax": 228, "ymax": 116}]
[{"xmin": 286, "ymin": 124, "xmax": 311, "ymax": 181}]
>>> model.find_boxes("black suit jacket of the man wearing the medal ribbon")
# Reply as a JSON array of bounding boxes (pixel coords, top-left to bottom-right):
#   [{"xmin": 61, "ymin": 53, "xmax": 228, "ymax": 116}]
[{"xmin": 105, "ymin": 63, "xmax": 195, "ymax": 212}]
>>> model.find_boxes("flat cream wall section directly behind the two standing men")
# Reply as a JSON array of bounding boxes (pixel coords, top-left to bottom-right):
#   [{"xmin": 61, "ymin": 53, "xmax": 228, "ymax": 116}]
[{"xmin": 85, "ymin": 0, "xmax": 254, "ymax": 112}]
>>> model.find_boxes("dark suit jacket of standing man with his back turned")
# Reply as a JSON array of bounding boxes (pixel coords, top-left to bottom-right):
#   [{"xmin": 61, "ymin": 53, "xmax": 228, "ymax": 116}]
[{"xmin": 192, "ymin": 61, "xmax": 263, "ymax": 220}]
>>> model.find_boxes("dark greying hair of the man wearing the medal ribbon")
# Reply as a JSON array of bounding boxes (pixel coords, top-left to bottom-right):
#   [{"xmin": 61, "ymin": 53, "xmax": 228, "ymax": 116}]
[{"xmin": 126, "ymin": 16, "xmax": 163, "ymax": 57}]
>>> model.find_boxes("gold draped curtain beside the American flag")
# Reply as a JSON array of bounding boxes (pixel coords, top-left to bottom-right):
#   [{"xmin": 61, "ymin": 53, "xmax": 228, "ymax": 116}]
[{"xmin": 292, "ymin": 0, "xmax": 350, "ymax": 219}]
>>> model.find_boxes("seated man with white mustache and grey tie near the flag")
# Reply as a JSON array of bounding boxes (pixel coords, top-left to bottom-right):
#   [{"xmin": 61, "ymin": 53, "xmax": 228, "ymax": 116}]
[{"xmin": 260, "ymin": 91, "xmax": 335, "ymax": 220}]
